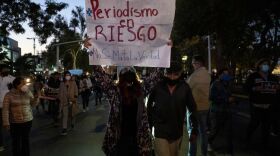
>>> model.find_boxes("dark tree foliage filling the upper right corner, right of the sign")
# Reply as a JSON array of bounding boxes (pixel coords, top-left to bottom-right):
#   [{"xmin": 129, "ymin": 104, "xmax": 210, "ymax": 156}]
[{"xmin": 172, "ymin": 0, "xmax": 280, "ymax": 69}]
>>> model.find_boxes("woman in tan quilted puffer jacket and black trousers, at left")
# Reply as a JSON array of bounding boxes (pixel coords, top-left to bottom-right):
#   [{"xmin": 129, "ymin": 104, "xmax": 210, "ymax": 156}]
[{"xmin": 2, "ymin": 77, "xmax": 40, "ymax": 156}]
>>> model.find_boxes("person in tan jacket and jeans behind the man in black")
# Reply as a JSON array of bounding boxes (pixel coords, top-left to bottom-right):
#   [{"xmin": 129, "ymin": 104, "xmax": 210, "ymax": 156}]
[{"xmin": 187, "ymin": 55, "xmax": 211, "ymax": 156}]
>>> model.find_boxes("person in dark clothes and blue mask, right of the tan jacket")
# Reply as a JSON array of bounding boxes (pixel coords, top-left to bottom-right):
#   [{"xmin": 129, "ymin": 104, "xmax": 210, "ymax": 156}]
[{"xmin": 208, "ymin": 69, "xmax": 233, "ymax": 156}]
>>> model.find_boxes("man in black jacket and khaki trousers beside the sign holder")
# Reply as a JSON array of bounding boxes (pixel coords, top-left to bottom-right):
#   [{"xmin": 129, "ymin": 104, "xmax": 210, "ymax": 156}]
[{"xmin": 147, "ymin": 61, "xmax": 198, "ymax": 156}]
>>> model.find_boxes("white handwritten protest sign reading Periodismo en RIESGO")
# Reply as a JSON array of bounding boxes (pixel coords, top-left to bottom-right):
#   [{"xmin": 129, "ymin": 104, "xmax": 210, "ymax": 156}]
[{"xmin": 86, "ymin": 0, "xmax": 176, "ymax": 67}]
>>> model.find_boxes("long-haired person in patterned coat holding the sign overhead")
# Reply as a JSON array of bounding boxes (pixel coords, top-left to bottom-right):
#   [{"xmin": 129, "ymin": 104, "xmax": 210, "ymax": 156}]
[{"xmin": 102, "ymin": 67, "xmax": 152, "ymax": 156}]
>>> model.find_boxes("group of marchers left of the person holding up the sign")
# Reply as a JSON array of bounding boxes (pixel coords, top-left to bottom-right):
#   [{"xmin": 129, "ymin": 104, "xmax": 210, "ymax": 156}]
[{"xmin": 0, "ymin": 65, "xmax": 106, "ymax": 156}]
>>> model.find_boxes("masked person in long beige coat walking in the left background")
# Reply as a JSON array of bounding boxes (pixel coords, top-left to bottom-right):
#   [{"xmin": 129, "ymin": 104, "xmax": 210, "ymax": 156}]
[{"xmin": 58, "ymin": 71, "xmax": 78, "ymax": 135}]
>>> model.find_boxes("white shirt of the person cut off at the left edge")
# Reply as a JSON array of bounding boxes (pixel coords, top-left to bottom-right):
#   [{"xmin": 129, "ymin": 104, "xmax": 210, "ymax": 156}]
[{"xmin": 0, "ymin": 75, "xmax": 15, "ymax": 108}]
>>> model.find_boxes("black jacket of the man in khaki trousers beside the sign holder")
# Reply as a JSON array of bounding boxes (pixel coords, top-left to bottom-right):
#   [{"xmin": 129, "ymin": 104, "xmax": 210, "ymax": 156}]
[{"xmin": 147, "ymin": 80, "xmax": 197, "ymax": 140}]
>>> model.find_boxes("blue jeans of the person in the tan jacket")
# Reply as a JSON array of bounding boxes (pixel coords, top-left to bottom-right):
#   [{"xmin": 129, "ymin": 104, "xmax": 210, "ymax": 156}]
[{"xmin": 187, "ymin": 111, "xmax": 208, "ymax": 156}]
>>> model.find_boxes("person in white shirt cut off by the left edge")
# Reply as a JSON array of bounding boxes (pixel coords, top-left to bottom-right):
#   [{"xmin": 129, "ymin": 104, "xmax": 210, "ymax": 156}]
[{"xmin": 0, "ymin": 65, "xmax": 15, "ymax": 151}]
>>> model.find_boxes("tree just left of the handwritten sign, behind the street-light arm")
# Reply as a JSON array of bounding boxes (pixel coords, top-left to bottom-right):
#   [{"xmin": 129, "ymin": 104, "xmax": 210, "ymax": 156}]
[{"xmin": 44, "ymin": 7, "xmax": 88, "ymax": 69}]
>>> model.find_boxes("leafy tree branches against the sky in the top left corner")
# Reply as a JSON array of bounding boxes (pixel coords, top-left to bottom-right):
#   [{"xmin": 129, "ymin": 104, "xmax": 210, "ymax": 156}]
[{"xmin": 0, "ymin": 0, "xmax": 67, "ymax": 43}]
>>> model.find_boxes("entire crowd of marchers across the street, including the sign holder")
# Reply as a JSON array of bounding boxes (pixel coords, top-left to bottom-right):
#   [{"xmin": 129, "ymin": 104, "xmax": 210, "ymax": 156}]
[{"xmin": 0, "ymin": 56, "xmax": 280, "ymax": 156}]
